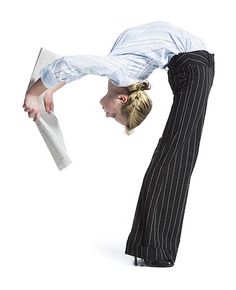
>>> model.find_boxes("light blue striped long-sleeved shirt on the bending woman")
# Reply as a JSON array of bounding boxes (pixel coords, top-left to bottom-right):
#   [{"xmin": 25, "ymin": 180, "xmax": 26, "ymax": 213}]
[{"xmin": 41, "ymin": 21, "xmax": 206, "ymax": 88}]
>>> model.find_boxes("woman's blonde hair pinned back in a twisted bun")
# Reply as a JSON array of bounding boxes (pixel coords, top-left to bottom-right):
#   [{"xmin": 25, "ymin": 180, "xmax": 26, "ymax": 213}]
[{"xmin": 121, "ymin": 80, "xmax": 152, "ymax": 135}]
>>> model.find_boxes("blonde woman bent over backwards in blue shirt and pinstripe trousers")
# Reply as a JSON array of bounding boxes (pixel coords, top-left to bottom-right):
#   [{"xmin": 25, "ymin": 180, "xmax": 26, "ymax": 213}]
[{"xmin": 23, "ymin": 21, "xmax": 214, "ymax": 267}]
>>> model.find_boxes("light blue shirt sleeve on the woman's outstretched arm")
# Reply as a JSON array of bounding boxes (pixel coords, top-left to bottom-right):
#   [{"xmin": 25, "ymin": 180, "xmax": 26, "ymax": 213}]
[{"xmin": 40, "ymin": 55, "xmax": 125, "ymax": 88}]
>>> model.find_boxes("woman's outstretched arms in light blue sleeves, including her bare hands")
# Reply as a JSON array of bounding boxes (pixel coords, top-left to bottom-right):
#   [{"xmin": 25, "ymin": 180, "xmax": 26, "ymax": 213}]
[{"xmin": 23, "ymin": 55, "xmax": 125, "ymax": 121}]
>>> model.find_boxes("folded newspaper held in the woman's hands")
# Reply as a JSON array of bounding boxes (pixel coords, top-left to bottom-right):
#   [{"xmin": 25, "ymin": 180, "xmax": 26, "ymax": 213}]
[{"xmin": 27, "ymin": 48, "xmax": 71, "ymax": 170}]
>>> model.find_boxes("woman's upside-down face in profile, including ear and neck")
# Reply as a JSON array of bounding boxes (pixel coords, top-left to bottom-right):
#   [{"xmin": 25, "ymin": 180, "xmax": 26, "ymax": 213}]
[{"xmin": 100, "ymin": 81, "xmax": 128, "ymax": 125}]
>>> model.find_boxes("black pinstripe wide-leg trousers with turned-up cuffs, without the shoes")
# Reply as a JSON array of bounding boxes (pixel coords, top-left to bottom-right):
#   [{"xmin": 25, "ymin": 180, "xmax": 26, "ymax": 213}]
[{"xmin": 125, "ymin": 50, "xmax": 215, "ymax": 262}]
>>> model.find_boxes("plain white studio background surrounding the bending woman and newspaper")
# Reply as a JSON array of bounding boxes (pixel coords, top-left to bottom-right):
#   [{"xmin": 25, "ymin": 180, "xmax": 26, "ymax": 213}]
[{"xmin": 0, "ymin": 0, "xmax": 236, "ymax": 290}]
